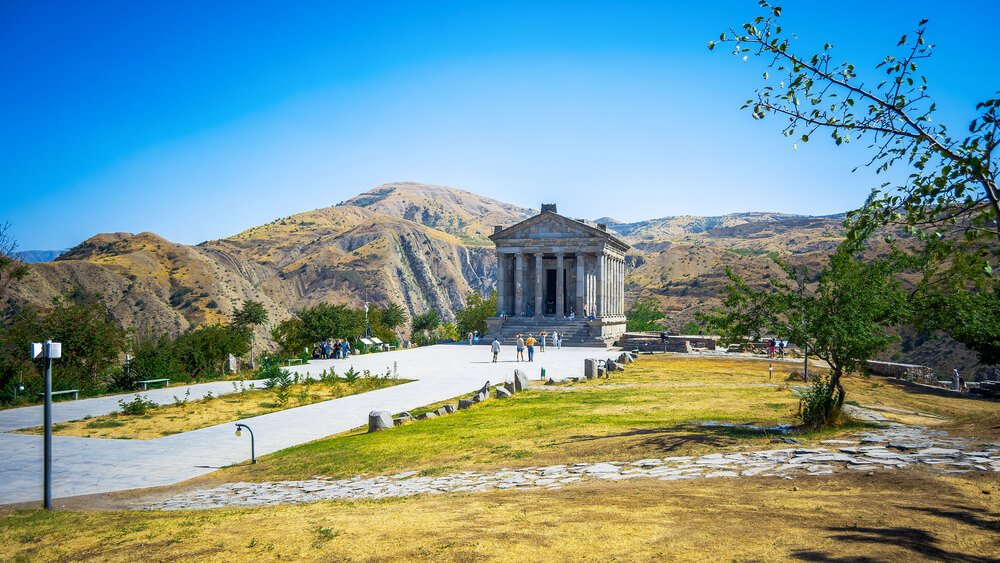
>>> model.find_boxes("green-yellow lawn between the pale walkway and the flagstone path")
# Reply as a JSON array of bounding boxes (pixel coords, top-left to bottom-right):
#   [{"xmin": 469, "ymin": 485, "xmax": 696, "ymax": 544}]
[{"xmin": 213, "ymin": 356, "xmax": 876, "ymax": 481}]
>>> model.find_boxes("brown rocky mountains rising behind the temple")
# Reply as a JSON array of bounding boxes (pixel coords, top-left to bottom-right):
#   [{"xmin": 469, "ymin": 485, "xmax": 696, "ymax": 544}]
[{"xmin": 9, "ymin": 182, "xmax": 992, "ymax": 382}]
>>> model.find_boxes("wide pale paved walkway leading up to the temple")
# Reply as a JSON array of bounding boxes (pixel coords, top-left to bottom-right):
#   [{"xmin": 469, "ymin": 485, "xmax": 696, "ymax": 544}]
[{"xmin": 0, "ymin": 345, "xmax": 600, "ymax": 506}]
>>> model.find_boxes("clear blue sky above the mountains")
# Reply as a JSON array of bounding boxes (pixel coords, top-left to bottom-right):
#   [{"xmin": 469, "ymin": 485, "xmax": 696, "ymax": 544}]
[{"xmin": 0, "ymin": 0, "xmax": 1000, "ymax": 249}]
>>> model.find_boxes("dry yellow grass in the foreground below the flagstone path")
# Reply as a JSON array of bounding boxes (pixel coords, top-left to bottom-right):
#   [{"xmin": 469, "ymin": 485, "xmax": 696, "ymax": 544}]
[{"xmin": 0, "ymin": 471, "xmax": 1000, "ymax": 561}]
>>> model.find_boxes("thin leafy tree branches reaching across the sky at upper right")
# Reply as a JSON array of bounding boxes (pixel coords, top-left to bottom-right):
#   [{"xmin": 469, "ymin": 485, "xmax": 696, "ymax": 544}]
[{"xmin": 708, "ymin": 0, "xmax": 1000, "ymax": 258}]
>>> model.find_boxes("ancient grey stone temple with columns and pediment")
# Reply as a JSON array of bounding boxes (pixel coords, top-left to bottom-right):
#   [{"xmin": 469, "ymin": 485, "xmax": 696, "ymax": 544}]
[{"xmin": 488, "ymin": 204, "xmax": 629, "ymax": 345}]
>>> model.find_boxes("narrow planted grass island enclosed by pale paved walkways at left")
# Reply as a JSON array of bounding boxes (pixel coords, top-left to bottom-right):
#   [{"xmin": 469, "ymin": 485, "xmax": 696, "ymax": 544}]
[{"xmin": 18, "ymin": 377, "xmax": 409, "ymax": 440}]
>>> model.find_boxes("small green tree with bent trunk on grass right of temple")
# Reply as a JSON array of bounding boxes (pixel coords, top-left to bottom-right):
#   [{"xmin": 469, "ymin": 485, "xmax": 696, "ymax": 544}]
[{"xmin": 710, "ymin": 242, "xmax": 908, "ymax": 425}]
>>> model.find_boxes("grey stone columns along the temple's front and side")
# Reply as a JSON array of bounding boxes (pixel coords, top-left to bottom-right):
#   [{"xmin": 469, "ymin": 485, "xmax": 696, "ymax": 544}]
[{"xmin": 497, "ymin": 252, "xmax": 625, "ymax": 317}]
